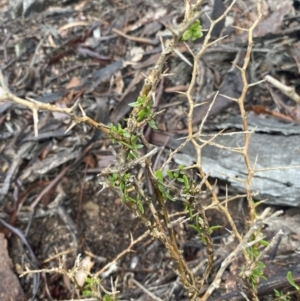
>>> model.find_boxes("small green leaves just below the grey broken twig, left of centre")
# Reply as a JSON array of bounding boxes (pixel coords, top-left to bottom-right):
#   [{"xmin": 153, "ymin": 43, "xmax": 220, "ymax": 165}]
[{"xmin": 109, "ymin": 173, "xmax": 144, "ymax": 214}]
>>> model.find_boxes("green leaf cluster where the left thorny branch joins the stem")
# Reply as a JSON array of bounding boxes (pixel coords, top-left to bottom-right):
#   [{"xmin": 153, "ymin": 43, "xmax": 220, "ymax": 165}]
[{"xmin": 110, "ymin": 123, "xmax": 144, "ymax": 160}]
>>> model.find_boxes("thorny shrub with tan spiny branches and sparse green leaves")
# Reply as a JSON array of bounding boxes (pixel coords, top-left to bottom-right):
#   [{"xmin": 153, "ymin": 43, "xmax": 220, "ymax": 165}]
[{"xmin": 1, "ymin": 0, "xmax": 297, "ymax": 301}]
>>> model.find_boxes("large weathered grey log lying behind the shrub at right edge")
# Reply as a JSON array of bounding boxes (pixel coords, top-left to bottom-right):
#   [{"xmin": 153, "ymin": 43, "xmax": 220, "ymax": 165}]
[{"xmin": 152, "ymin": 112, "xmax": 300, "ymax": 207}]
